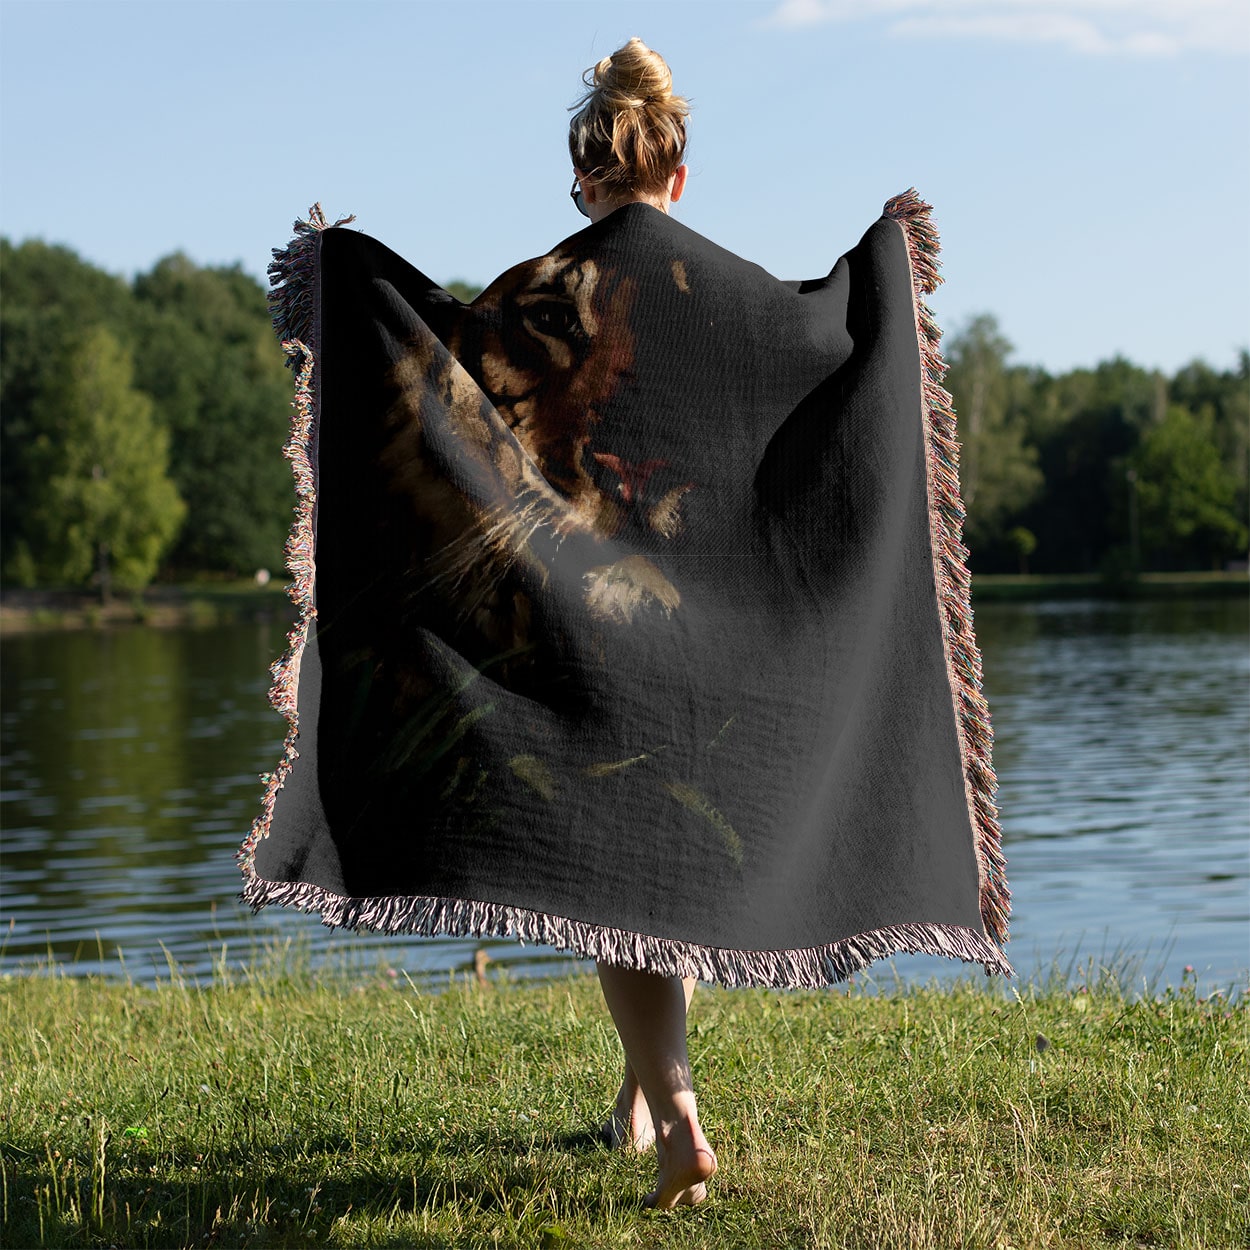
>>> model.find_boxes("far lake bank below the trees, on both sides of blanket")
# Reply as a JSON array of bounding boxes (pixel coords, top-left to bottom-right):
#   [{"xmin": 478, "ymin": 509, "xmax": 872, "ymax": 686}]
[{"xmin": 0, "ymin": 571, "xmax": 1250, "ymax": 635}]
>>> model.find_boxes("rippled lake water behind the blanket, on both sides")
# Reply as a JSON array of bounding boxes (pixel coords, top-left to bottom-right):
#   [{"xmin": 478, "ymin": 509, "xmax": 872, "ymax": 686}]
[{"xmin": 0, "ymin": 600, "xmax": 1250, "ymax": 988}]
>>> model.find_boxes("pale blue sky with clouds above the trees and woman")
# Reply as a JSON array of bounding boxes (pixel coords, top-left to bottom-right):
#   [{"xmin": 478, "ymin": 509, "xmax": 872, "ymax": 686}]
[{"xmin": 0, "ymin": 0, "xmax": 1250, "ymax": 371}]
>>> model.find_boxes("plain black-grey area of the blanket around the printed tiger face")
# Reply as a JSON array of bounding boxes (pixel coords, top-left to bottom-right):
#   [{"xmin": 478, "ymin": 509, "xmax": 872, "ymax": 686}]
[{"xmin": 256, "ymin": 206, "xmax": 980, "ymax": 949}]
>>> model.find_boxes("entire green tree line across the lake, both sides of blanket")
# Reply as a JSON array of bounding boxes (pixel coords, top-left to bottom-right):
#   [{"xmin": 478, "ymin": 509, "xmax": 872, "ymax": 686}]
[{"xmin": 0, "ymin": 239, "xmax": 1250, "ymax": 595}]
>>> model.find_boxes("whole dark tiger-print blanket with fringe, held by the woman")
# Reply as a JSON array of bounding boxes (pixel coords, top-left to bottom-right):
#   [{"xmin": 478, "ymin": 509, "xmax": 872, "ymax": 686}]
[{"xmin": 240, "ymin": 191, "xmax": 1011, "ymax": 986}]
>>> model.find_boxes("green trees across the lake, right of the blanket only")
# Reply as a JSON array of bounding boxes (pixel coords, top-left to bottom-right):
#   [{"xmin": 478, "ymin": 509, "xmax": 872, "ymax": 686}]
[{"xmin": 945, "ymin": 316, "xmax": 1250, "ymax": 578}]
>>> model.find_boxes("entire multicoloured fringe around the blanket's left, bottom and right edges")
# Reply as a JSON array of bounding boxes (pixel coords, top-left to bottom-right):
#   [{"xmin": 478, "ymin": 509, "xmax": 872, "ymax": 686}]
[{"xmin": 239, "ymin": 200, "xmax": 1013, "ymax": 989}]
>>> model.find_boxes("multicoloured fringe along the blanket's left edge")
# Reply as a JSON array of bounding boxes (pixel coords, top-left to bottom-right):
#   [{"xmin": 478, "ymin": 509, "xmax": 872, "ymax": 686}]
[{"xmin": 238, "ymin": 204, "xmax": 355, "ymax": 894}]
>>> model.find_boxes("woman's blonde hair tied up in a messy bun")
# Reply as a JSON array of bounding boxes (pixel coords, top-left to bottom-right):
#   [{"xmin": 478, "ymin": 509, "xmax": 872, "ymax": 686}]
[{"xmin": 569, "ymin": 38, "xmax": 690, "ymax": 195}]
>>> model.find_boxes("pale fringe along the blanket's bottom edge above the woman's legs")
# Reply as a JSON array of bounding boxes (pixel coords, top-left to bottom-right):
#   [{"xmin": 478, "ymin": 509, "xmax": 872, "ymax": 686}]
[{"xmin": 236, "ymin": 874, "xmax": 1013, "ymax": 989}]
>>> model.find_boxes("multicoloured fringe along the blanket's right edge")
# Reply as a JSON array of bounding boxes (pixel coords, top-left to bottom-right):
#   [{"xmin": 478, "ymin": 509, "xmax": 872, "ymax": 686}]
[{"xmin": 883, "ymin": 188, "xmax": 1011, "ymax": 943}]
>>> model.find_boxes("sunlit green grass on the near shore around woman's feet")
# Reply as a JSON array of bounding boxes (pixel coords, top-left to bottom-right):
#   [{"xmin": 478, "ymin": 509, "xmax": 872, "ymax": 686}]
[{"xmin": 0, "ymin": 966, "xmax": 1250, "ymax": 1250}]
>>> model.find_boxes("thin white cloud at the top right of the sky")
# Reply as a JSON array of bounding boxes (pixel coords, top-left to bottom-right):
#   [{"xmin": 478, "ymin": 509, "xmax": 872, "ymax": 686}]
[{"xmin": 769, "ymin": 0, "xmax": 1250, "ymax": 58}]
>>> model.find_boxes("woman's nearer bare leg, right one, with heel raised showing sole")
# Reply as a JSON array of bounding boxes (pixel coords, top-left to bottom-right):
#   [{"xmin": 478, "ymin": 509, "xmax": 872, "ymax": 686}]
[{"xmin": 598, "ymin": 963, "xmax": 716, "ymax": 1208}]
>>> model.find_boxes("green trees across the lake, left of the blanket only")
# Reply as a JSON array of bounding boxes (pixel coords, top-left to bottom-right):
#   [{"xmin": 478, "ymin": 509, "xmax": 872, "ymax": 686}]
[{"xmin": 0, "ymin": 240, "xmax": 293, "ymax": 591}]
